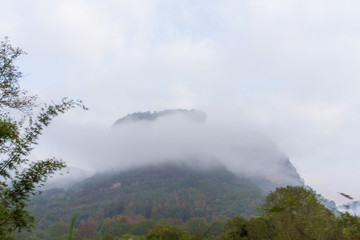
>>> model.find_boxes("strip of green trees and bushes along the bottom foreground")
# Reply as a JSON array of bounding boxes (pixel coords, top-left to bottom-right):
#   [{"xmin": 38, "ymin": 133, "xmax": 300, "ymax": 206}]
[{"xmin": 18, "ymin": 186, "xmax": 360, "ymax": 240}]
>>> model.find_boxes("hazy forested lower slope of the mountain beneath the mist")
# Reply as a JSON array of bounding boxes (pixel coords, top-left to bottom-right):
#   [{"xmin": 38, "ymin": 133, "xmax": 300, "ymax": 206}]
[{"xmin": 30, "ymin": 164, "xmax": 264, "ymax": 228}]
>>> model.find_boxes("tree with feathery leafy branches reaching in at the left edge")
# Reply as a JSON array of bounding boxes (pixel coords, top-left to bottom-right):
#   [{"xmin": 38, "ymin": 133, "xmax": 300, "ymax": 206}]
[{"xmin": 0, "ymin": 38, "xmax": 85, "ymax": 239}]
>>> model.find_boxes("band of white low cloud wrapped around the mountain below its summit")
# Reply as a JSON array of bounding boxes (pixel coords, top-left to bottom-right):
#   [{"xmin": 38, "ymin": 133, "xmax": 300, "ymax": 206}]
[{"xmin": 36, "ymin": 109, "xmax": 299, "ymax": 187}]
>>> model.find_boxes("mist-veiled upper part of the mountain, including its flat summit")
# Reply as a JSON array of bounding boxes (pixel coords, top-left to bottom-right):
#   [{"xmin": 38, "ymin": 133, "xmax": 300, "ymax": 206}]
[{"xmin": 112, "ymin": 109, "xmax": 303, "ymax": 188}]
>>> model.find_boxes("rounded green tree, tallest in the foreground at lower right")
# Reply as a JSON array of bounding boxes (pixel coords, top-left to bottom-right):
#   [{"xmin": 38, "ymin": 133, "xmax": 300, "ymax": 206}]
[{"xmin": 262, "ymin": 186, "xmax": 342, "ymax": 240}]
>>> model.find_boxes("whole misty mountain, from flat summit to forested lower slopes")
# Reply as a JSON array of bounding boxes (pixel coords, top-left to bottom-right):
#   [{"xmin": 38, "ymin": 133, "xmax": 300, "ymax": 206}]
[{"xmin": 29, "ymin": 109, "xmax": 304, "ymax": 227}]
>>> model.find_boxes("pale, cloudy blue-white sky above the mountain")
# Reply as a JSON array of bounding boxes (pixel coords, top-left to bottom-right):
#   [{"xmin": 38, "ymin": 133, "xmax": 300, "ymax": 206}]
[{"xmin": 0, "ymin": 0, "xmax": 360, "ymax": 204}]
